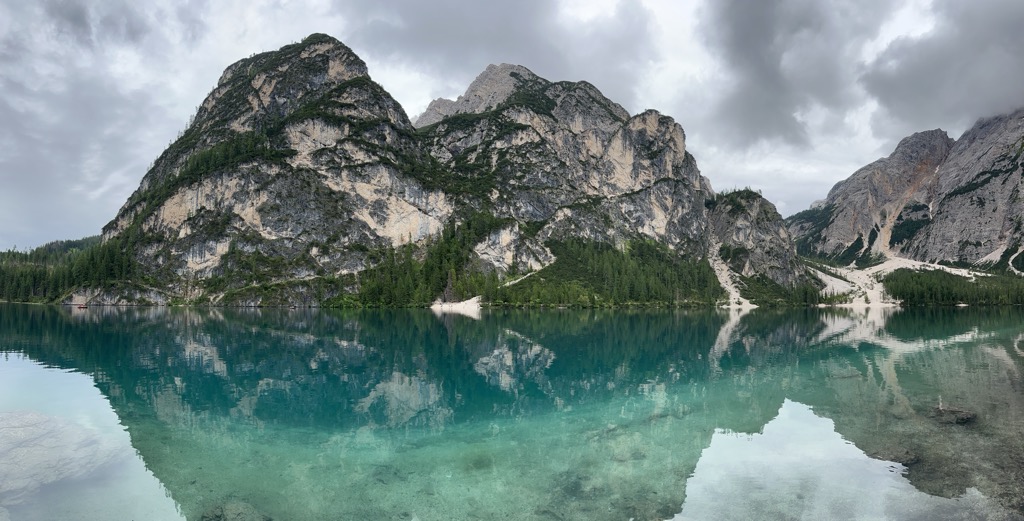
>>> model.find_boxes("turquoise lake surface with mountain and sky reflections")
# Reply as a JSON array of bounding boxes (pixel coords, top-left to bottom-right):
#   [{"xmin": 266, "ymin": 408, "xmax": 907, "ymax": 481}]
[{"xmin": 0, "ymin": 304, "xmax": 1024, "ymax": 521}]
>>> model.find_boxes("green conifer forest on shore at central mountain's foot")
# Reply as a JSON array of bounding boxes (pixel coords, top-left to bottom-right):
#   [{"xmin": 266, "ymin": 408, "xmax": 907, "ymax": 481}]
[{"xmin": 350, "ymin": 214, "xmax": 725, "ymax": 307}]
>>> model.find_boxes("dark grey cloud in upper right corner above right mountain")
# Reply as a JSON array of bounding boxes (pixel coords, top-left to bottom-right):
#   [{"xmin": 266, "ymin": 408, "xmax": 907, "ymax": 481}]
[{"xmin": 861, "ymin": 0, "xmax": 1024, "ymax": 139}]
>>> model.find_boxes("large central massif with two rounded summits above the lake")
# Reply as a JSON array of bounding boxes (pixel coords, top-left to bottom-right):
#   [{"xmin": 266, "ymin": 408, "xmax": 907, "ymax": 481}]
[{"xmin": 93, "ymin": 35, "xmax": 806, "ymax": 305}]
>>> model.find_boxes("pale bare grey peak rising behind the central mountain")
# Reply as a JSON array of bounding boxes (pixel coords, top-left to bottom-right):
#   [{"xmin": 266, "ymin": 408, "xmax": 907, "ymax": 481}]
[{"xmin": 414, "ymin": 63, "xmax": 547, "ymax": 127}]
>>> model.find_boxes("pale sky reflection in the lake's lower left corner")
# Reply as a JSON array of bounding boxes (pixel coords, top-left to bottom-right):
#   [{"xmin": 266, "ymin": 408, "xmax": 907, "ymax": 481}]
[{"xmin": 0, "ymin": 353, "xmax": 183, "ymax": 521}]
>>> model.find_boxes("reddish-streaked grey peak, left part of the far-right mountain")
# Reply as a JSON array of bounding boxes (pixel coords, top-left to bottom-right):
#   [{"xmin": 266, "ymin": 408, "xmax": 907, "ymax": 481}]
[{"xmin": 788, "ymin": 130, "xmax": 953, "ymax": 257}]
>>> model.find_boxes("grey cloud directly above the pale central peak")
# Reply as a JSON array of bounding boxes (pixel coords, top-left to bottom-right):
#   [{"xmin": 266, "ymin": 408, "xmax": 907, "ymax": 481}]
[{"xmin": 337, "ymin": 0, "xmax": 657, "ymax": 114}]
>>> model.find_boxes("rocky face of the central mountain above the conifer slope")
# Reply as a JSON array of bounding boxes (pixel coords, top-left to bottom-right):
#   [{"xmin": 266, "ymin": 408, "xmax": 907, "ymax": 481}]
[{"xmin": 420, "ymin": 66, "xmax": 714, "ymax": 267}]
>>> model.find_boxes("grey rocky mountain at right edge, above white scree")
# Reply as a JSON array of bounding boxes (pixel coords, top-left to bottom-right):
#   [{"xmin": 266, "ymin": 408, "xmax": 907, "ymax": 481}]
[{"xmin": 786, "ymin": 110, "xmax": 1024, "ymax": 265}]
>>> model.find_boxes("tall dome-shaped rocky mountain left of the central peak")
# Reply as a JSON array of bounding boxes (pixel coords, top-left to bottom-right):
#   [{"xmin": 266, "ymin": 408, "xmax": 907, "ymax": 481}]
[{"xmin": 103, "ymin": 35, "xmax": 453, "ymax": 302}]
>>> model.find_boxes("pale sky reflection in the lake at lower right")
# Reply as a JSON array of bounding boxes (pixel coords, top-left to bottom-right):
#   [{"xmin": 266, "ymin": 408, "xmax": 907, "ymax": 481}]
[{"xmin": 673, "ymin": 400, "xmax": 1001, "ymax": 521}]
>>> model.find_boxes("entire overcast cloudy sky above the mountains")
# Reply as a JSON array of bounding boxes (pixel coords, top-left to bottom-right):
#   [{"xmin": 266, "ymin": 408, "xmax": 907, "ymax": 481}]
[{"xmin": 0, "ymin": 0, "xmax": 1024, "ymax": 250}]
